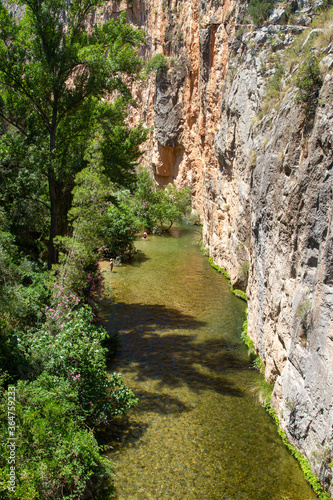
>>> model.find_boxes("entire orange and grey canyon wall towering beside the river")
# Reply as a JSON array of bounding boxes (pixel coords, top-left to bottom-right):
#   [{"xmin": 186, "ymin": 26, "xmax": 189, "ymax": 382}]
[{"xmin": 103, "ymin": 0, "xmax": 333, "ymax": 491}]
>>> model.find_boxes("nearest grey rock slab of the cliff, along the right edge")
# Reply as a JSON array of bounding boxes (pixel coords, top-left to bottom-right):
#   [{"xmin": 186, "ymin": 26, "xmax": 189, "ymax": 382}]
[{"xmin": 248, "ymin": 75, "xmax": 333, "ymax": 488}]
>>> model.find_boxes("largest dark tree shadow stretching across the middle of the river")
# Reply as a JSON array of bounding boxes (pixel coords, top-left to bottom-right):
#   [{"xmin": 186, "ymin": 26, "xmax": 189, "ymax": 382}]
[{"xmin": 106, "ymin": 303, "xmax": 249, "ymax": 397}]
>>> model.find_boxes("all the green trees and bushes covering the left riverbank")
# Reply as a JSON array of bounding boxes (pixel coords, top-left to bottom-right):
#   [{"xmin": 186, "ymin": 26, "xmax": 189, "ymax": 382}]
[{"xmin": 0, "ymin": 0, "xmax": 189, "ymax": 500}]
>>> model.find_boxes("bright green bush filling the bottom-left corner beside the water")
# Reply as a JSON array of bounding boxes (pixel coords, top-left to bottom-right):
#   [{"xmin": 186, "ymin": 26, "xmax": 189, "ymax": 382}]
[{"xmin": 0, "ymin": 373, "xmax": 113, "ymax": 500}]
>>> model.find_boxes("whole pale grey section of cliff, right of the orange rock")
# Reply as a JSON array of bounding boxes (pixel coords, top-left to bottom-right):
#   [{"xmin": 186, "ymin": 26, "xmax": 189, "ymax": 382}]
[{"xmin": 210, "ymin": 16, "xmax": 333, "ymax": 492}]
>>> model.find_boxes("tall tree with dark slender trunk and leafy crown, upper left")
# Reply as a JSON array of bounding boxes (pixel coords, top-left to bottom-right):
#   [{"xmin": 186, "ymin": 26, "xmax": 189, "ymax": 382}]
[{"xmin": 0, "ymin": 0, "xmax": 143, "ymax": 268}]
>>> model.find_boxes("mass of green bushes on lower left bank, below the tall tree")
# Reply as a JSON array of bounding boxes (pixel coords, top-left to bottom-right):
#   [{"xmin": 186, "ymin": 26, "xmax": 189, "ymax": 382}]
[{"xmin": 0, "ymin": 241, "xmax": 137, "ymax": 500}]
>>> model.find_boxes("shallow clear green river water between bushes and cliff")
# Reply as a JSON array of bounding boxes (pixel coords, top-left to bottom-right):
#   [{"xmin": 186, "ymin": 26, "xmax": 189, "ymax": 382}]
[{"xmin": 99, "ymin": 229, "xmax": 316, "ymax": 500}]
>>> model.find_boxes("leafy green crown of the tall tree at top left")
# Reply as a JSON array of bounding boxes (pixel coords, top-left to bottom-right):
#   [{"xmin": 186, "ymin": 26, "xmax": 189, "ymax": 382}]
[{"xmin": 0, "ymin": 0, "xmax": 143, "ymax": 132}]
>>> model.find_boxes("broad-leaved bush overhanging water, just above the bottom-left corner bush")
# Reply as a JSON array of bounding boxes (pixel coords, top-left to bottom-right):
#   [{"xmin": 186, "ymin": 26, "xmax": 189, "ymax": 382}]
[{"xmin": 20, "ymin": 304, "xmax": 137, "ymax": 427}]
